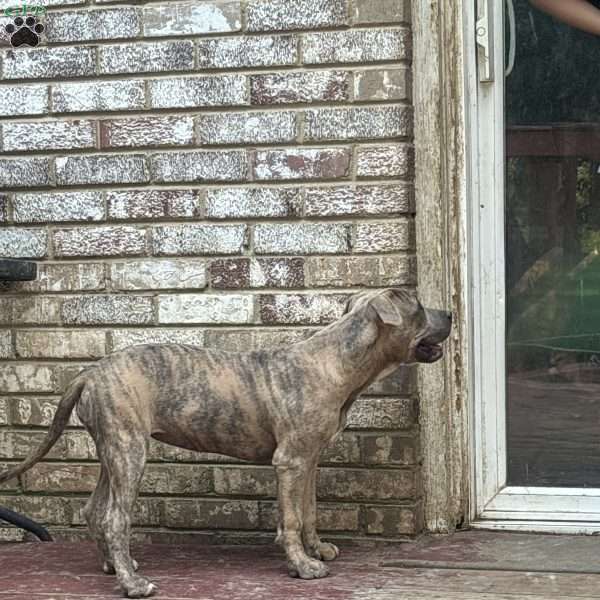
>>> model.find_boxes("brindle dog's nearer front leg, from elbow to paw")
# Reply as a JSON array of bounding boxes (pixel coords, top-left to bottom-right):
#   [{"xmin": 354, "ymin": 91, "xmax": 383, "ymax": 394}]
[{"xmin": 273, "ymin": 448, "xmax": 329, "ymax": 579}]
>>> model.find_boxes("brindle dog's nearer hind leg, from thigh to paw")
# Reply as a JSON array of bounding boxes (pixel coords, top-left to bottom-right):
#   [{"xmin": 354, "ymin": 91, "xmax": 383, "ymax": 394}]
[{"xmin": 98, "ymin": 430, "xmax": 156, "ymax": 598}]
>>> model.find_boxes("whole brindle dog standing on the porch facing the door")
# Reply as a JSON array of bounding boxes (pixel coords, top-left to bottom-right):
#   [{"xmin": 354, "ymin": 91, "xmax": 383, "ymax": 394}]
[{"xmin": 0, "ymin": 289, "xmax": 452, "ymax": 598}]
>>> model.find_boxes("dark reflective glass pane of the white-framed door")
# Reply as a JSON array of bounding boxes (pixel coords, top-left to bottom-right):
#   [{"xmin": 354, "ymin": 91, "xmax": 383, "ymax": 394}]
[{"xmin": 505, "ymin": 0, "xmax": 600, "ymax": 487}]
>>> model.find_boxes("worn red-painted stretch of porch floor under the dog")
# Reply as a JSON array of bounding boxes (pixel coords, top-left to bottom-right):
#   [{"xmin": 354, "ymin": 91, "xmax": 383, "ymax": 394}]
[{"xmin": 0, "ymin": 542, "xmax": 391, "ymax": 600}]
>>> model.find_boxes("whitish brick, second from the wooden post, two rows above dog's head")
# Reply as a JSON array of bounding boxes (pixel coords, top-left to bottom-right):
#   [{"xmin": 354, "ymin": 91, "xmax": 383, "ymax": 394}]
[{"xmin": 254, "ymin": 223, "xmax": 349, "ymax": 254}]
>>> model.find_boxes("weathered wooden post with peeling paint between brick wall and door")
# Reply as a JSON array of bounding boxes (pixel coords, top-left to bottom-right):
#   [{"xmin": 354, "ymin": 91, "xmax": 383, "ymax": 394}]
[{"xmin": 412, "ymin": 0, "xmax": 473, "ymax": 533}]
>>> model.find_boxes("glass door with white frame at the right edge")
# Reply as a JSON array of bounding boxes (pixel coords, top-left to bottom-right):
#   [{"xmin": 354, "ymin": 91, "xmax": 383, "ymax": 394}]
[{"xmin": 472, "ymin": 0, "xmax": 600, "ymax": 532}]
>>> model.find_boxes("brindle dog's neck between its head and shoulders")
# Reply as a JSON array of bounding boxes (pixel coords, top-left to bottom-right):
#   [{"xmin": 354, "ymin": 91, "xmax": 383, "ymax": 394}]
[{"xmin": 302, "ymin": 311, "xmax": 397, "ymax": 395}]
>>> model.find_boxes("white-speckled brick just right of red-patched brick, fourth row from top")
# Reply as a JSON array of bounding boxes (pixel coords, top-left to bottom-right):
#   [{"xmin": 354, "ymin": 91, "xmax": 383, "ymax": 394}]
[{"xmin": 198, "ymin": 112, "xmax": 297, "ymax": 144}]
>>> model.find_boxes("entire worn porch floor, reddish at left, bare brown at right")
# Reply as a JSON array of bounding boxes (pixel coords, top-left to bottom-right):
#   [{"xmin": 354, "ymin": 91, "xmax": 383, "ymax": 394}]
[{"xmin": 0, "ymin": 531, "xmax": 600, "ymax": 600}]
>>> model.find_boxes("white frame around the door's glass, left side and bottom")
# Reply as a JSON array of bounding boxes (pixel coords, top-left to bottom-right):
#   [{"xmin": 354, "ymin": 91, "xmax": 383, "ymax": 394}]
[{"xmin": 465, "ymin": 0, "xmax": 600, "ymax": 533}]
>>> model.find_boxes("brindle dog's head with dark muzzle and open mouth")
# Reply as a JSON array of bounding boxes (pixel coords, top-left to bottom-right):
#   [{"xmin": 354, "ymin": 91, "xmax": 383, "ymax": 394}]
[{"xmin": 344, "ymin": 288, "xmax": 452, "ymax": 363}]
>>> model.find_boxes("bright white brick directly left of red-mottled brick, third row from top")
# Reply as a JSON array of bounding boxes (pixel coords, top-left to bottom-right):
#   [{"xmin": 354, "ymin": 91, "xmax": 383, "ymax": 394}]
[{"xmin": 149, "ymin": 75, "xmax": 249, "ymax": 108}]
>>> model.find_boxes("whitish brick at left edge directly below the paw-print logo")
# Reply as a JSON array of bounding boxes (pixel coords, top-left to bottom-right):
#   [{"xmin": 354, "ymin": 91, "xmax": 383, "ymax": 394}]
[{"xmin": 2, "ymin": 47, "xmax": 96, "ymax": 79}]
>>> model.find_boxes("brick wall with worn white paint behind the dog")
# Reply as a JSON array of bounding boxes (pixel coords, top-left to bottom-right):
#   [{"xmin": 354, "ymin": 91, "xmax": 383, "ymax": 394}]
[{"xmin": 0, "ymin": 0, "xmax": 420, "ymax": 538}]
